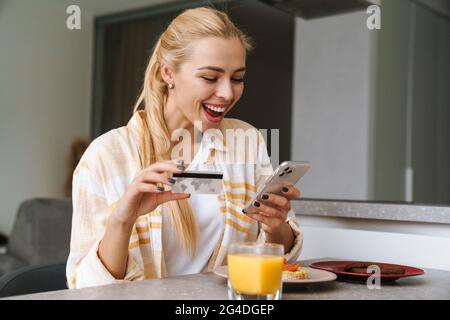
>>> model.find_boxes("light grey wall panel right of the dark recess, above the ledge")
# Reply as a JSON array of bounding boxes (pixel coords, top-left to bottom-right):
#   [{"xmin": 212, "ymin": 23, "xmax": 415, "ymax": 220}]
[{"xmin": 292, "ymin": 11, "xmax": 377, "ymax": 200}]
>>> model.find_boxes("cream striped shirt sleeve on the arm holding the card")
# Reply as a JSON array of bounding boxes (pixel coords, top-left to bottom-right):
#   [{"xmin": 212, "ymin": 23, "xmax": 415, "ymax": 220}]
[{"xmin": 66, "ymin": 144, "xmax": 142, "ymax": 289}]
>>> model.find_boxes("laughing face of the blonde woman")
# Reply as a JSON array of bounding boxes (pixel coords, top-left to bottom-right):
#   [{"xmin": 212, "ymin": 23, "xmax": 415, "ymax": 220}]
[{"xmin": 162, "ymin": 37, "xmax": 246, "ymax": 132}]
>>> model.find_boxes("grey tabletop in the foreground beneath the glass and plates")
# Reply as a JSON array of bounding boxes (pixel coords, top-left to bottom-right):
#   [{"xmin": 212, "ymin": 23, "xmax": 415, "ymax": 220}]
[{"xmin": 4, "ymin": 259, "xmax": 450, "ymax": 300}]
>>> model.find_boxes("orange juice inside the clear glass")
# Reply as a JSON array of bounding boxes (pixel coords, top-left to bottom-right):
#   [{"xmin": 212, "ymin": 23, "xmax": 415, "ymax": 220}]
[{"xmin": 228, "ymin": 253, "xmax": 283, "ymax": 295}]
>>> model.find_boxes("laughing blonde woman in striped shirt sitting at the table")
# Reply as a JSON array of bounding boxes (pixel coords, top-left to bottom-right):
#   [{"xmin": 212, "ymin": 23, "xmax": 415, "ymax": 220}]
[{"xmin": 67, "ymin": 8, "xmax": 302, "ymax": 288}]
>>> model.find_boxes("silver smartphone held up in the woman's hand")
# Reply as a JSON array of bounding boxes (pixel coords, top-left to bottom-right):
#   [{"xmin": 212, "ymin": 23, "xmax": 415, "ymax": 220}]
[{"xmin": 242, "ymin": 161, "xmax": 311, "ymax": 213}]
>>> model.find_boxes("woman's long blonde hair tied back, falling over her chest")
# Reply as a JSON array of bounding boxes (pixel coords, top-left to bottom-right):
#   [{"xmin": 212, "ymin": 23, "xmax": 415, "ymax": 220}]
[{"xmin": 134, "ymin": 7, "xmax": 252, "ymax": 255}]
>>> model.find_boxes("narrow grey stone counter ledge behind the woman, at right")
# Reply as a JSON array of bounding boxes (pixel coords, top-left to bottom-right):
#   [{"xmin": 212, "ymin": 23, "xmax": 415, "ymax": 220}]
[{"xmin": 292, "ymin": 199, "xmax": 450, "ymax": 224}]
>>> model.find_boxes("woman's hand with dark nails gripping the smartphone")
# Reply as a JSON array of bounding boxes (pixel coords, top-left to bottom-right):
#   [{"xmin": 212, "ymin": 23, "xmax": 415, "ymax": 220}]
[{"xmin": 247, "ymin": 185, "xmax": 300, "ymax": 238}]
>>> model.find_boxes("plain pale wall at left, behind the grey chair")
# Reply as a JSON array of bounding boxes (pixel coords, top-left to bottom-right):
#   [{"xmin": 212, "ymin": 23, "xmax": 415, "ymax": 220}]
[{"xmin": 0, "ymin": 0, "xmax": 174, "ymax": 234}]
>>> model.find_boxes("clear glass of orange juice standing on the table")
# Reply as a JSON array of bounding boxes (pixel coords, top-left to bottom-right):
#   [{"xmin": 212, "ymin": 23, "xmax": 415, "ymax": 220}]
[{"xmin": 228, "ymin": 242, "xmax": 284, "ymax": 300}]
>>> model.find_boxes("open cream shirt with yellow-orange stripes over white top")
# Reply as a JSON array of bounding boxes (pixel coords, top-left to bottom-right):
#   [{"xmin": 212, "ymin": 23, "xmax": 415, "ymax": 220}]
[{"xmin": 66, "ymin": 111, "xmax": 303, "ymax": 288}]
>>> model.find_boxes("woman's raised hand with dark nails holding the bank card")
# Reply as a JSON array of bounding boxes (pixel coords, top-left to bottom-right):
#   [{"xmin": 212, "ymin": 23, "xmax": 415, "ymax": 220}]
[{"xmin": 113, "ymin": 160, "xmax": 190, "ymax": 224}]
